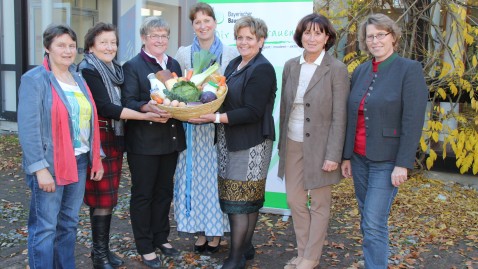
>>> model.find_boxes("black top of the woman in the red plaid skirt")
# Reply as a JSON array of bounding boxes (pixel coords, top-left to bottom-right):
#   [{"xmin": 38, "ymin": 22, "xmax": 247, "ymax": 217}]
[{"xmin": 78, "ymin": 60, "xmax": 123, "ymax": 120}]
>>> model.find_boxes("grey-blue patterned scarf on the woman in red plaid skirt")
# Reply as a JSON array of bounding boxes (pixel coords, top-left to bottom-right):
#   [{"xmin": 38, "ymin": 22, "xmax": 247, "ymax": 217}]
[{"xmin": 85, "ymin": 53, "xmax": 124, "ymax": 136}]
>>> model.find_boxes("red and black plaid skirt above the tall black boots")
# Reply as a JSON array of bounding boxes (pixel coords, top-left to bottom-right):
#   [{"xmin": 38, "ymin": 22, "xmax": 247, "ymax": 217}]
[{"xmin": 83, "ymin": 118, "xmax": 124, "ymax": 208}]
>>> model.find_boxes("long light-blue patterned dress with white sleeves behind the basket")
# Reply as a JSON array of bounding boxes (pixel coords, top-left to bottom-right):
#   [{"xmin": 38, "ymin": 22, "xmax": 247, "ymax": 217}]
[{"xmin": 174, "ymin": 43, "xmax": 238, "ymax": 236}]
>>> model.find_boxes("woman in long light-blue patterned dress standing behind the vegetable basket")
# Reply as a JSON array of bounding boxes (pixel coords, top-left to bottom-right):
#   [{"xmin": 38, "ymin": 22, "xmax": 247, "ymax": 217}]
[{"xmin": 174, "ymin": 2, "xmax": 239, "ymax": 252}]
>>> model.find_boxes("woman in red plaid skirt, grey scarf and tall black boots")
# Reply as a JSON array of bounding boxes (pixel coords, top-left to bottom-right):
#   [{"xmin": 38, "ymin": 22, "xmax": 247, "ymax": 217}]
[{"xmin": 79, "ymin": 22, "xmax": 161, "ymax": 268}]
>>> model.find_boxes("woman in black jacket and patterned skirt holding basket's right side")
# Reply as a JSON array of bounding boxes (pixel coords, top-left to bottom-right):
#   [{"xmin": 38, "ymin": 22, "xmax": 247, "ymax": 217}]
[{"xmin": 191, "ymin": 16, "xmax": 277, "ymax": 269}]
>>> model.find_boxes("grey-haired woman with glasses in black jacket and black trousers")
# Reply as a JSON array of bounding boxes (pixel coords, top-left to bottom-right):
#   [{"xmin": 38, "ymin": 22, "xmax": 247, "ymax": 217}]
[{"xmin": 121, "ymin": 17, "xmax": 186, "ymax": 268}]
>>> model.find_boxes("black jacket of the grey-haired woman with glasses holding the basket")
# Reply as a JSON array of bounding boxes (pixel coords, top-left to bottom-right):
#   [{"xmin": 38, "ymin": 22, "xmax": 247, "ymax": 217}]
[{"xmin": 121, "ymin": 53, "xmax": 186, "ymax": 155}]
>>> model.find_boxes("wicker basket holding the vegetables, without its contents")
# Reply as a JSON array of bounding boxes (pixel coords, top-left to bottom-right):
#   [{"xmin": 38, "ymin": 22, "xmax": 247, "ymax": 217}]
[{"xmin": 158, "ymin": 88, "xmax": 228, "ymax": 121}]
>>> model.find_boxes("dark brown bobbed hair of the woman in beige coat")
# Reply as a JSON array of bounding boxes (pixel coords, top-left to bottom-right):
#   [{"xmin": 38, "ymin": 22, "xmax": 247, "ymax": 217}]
[{"xmin": 294, "ymin": 13, "xmax": 337, "ymax": 51}]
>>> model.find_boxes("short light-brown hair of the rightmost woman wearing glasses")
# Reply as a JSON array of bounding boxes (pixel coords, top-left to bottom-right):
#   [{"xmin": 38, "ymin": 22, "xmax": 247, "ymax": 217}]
[{"xmin": 358, "ymin": 13, "xmax": 402, "ymax": 53}]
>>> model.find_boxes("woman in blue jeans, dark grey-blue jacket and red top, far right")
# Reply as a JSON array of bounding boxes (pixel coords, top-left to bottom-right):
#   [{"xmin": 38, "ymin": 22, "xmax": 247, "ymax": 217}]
[{"xmin": 342, "ymin": 14, "xmax": 428, "ymax": 269}]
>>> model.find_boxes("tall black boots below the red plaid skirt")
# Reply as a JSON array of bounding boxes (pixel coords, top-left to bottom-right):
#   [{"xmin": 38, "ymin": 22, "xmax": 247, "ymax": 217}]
[{"xmin": 90, "ymin": 213, "xmax": 124, "ymax": 269}]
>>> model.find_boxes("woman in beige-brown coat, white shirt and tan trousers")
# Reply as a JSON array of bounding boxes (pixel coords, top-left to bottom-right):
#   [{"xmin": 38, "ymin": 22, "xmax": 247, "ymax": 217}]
[{"xmin": 279, "ymin": 14, "xmax": 349, "ymax": 269}]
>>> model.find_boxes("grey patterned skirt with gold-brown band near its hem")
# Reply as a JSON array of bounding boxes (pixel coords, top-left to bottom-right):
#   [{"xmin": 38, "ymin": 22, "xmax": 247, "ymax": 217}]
[{"xmin": 217, "ymin": 125, "xmax": 272, "ymax": 214}]
